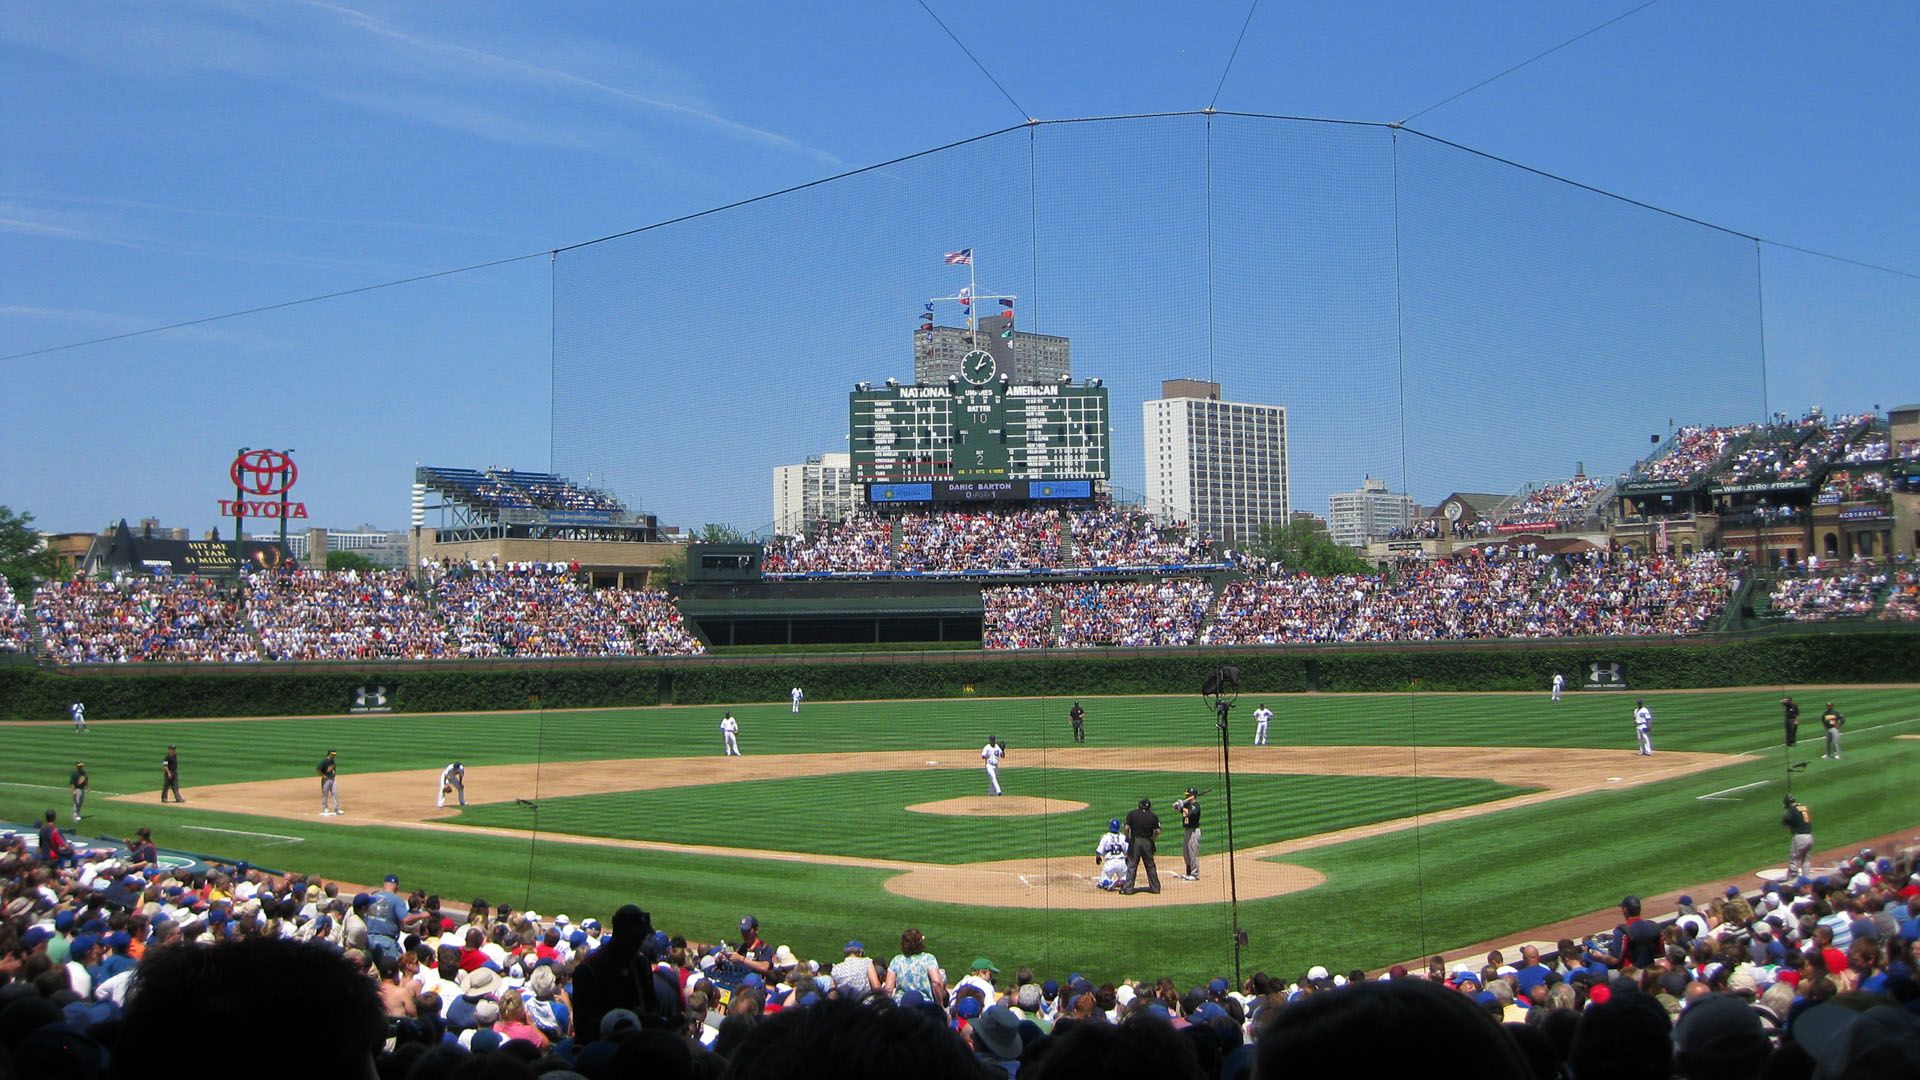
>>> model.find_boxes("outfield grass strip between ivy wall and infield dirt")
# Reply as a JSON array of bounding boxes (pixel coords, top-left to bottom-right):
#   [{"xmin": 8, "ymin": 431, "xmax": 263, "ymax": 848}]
[{"xmin": 0, "ymin": 690, "xmax": 1920, "ymax": 792}]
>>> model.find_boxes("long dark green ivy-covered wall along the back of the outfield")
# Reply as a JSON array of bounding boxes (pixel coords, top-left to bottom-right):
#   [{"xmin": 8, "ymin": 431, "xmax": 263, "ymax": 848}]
[{"xmin": 0, "ymin": 623, "xmax": 1920, "ymax": 721}]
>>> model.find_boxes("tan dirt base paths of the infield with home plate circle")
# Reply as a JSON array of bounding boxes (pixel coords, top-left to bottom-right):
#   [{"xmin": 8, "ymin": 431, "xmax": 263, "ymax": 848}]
[{"xmin": 117, "ymin": 746, "xmax": 1740, "ymax": 911}]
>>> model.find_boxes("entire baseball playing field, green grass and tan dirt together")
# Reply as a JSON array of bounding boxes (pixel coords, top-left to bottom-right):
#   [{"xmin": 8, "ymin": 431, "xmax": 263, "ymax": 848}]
[{"xmin": 0, "ymin": 686, "xmax": 1920, "ymax": 982}]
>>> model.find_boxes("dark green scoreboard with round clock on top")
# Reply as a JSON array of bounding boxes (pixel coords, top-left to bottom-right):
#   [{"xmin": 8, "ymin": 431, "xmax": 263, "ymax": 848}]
[{"xmin": 847, "ymin": 352, "xmax": 1112, "ymax": 484}]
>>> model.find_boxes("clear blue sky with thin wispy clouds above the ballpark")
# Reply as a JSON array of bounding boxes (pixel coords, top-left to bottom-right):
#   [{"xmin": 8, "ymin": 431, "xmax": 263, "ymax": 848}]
[{"xmin": 0, "ymin": 0, "xmax": 1920, "ymax": 530}]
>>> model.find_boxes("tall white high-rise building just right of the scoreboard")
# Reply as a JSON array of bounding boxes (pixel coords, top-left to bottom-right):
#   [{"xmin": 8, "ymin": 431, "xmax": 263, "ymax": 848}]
[{"xmin": 1142, "ymin": 379, "xmax": 1290, "ymax": 544}]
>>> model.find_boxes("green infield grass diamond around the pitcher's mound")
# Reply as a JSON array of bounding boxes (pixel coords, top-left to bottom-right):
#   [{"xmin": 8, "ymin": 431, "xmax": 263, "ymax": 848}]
[{"xmin": 457, "ymin": 769, "xmax": 1530, "ymax": 863}]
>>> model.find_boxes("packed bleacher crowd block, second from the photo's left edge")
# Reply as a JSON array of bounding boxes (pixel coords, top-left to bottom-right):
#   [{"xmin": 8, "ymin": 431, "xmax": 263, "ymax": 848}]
[{"xmin": 33, "ymin": 575, "xmax": 259, "ymax": 663}]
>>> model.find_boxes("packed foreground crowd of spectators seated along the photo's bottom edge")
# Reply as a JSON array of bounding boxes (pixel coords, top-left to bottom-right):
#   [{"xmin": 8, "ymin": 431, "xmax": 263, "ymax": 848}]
[{"xmin": 0, "ymin": 811, "xmax": 1920, "ymax": 1080}]
